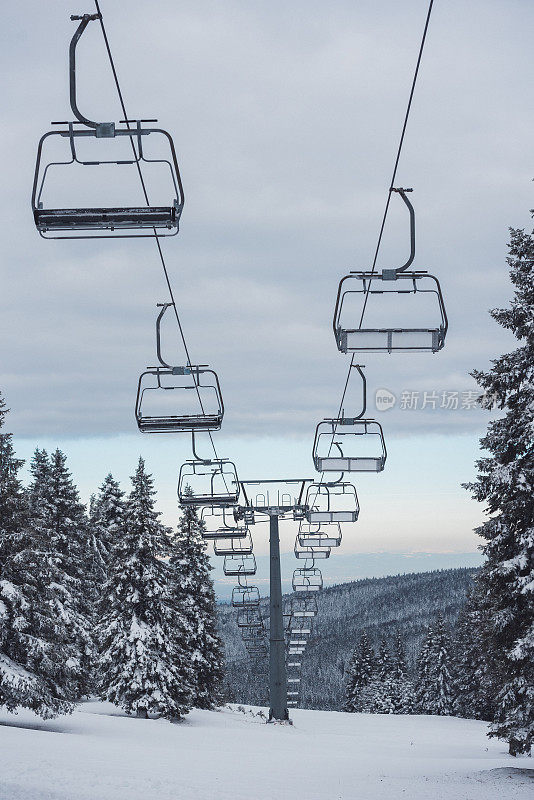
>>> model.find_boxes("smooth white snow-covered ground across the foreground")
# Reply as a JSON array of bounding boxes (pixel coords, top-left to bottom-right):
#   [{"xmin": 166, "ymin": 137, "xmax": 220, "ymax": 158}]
[{"xmin": 0, "ymin": 702, "xmax": 534, "ymax": 800}]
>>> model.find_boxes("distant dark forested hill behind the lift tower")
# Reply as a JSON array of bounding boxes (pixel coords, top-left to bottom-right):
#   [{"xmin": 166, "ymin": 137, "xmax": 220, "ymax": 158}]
[{"xmin": 219, "ymin": 568, "xmax": 476, "ymax": 709}]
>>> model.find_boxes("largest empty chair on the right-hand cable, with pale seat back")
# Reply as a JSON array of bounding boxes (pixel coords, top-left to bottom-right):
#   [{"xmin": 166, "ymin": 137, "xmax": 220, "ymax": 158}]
[{"xmin": 333, "ymin": 189, "xmax": 448, "ymax": 353}]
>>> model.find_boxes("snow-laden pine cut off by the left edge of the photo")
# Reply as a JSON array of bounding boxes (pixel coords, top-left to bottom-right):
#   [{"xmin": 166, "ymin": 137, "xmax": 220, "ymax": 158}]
[{"xmin": 0, "ymin": 395, "xmax": 72, "ymax": 718}]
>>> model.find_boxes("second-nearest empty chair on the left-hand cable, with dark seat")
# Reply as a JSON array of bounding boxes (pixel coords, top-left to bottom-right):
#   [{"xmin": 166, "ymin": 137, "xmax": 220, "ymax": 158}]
[{"xmin": 135, "ymin": 303, "xmax": 224, "ymax": 432}]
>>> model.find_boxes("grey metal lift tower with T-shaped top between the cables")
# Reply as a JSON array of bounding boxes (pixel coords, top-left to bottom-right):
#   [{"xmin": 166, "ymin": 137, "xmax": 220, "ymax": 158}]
[{"xmin": 237, "ymin": 478, "xmax": 311, "ymax": 720}]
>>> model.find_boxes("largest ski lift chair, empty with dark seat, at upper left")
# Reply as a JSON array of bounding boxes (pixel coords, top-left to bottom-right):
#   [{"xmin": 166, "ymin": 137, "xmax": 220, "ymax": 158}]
[{"xmin": 31, "ymin": 14, "xmax": 184, "ymax": 239}]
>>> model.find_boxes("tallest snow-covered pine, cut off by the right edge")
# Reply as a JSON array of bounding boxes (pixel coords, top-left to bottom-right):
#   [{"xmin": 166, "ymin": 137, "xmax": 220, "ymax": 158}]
[{"xmin": 467, "ymin": 219, "xmax": 534, "ymax": 755}]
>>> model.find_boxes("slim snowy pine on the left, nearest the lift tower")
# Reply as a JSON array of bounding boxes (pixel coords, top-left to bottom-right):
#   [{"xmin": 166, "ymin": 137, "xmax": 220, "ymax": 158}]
[{"xmin": 169, "ymin": 487, "xmax": 224, "ymax": 709}]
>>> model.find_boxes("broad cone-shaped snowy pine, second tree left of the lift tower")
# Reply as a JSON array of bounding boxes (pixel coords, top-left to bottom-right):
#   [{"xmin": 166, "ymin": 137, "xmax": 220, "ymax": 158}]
[{"xmin": 100, "ymin": 458, "xmax": 193, "ymax": 720}]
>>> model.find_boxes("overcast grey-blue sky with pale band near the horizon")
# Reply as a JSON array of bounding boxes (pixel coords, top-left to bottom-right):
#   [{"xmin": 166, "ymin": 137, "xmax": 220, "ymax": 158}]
[{"xmin": 0, "ymin": 0, "xmax": 534, "ymax": 569}]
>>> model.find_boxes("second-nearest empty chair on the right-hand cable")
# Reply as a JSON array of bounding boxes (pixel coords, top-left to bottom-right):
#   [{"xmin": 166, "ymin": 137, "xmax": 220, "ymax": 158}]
[{"xmin": 312, "ymin": 364, "xmax": 387, "ymax": 473}]
